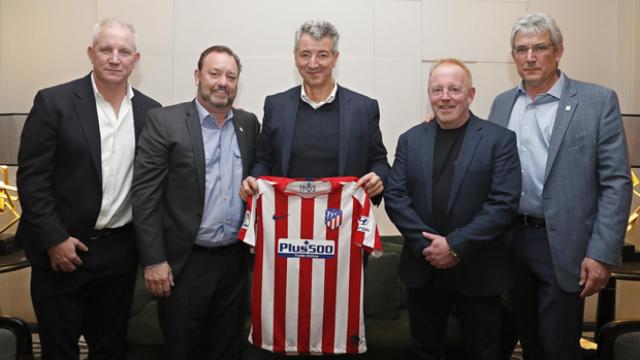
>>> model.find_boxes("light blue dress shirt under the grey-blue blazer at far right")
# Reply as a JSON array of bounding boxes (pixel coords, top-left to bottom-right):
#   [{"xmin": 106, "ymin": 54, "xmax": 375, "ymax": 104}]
[{"xmin": 509, "ymin": 73, "xmax": 565, "ymax": 217}]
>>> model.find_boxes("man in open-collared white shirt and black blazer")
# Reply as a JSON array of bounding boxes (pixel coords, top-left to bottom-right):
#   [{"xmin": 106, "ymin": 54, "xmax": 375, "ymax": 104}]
[{"xmin": 16, "ymin": 19, "xmax": 160, "ymax": 359}]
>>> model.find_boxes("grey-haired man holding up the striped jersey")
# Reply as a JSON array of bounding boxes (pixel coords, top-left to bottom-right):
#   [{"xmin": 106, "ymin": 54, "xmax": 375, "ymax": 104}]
[{"xmin": 242, "ymin": 21, "xmax": 389, "ymax": 203}]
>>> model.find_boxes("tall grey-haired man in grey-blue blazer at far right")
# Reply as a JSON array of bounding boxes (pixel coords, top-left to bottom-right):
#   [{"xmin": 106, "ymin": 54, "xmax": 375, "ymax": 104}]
[{"xmin": 489, "ymin": 14, "xmax": 631, "ymax": 360}]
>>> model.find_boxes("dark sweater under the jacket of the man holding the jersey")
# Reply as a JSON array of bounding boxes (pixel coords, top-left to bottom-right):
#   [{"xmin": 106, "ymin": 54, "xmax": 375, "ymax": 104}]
[{"xmin": 287, "ymin": 97, "xmax": 340, "ymax": 178}]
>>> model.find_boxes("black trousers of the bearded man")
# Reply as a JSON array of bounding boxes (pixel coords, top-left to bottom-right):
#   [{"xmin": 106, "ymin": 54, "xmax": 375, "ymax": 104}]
[{"xmin": 158, "ymin": 242, "xmax": 248, "ymax": 360}]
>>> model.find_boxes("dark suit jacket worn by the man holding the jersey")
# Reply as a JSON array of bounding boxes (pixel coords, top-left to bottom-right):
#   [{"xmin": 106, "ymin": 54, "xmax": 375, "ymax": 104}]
[{"xmin": 251, "ymin": 86, "xmax": 389, "ymax": 202}]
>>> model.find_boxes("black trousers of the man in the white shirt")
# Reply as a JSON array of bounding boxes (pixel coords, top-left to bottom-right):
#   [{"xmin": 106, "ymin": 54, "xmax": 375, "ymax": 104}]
[{"xmin": 31, "ymin": 225, "xmax": 137, "ymax": 360}]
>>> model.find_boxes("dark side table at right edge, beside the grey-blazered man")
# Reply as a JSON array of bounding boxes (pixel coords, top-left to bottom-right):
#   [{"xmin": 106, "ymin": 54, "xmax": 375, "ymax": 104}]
[{"xmin": 596, "ymin": 261, "xmax": 640, "ymax": 338}]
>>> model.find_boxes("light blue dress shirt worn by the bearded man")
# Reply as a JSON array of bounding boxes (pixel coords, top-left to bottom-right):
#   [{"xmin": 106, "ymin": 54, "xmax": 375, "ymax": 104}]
[{"xmin": 195, "ymin": 99, "xmax": 244, "ymax": 247}]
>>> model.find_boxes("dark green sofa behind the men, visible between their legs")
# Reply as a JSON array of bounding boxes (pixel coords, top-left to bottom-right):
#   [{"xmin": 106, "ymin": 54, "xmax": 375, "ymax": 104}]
[{"xmin": 127, "ymin": 236, "xmax": 515, "ymax": 360}]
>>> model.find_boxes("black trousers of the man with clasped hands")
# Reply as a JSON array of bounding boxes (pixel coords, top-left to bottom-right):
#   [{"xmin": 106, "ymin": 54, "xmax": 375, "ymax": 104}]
[{"xmin": 408, "ymin": 270, "xmax": 501, "ymax": 360}]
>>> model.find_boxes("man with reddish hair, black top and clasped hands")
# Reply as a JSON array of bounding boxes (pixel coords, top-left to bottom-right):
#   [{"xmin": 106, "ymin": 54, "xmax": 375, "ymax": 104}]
[{"xmin": 385, "ymin": 59, "xmax": 521, "ymax": 360}]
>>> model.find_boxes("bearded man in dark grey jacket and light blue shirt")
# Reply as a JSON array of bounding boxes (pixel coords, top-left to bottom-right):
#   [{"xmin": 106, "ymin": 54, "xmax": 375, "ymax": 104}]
[{"xmin": 132, "ymin": 46, "xmax": 260, "ymax": 360}]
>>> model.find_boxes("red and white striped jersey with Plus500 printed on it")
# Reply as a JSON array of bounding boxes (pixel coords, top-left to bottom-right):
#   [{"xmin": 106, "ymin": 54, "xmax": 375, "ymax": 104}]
[{"xmin": 239, "ymin": 177, "xmax": 382, "ymax": 354}]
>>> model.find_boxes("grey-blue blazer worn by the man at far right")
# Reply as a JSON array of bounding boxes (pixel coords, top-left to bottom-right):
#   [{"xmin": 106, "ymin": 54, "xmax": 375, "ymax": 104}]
[{"xmin": 488, "ymin": 77, "xmax": 632, "ymax": 291}]
